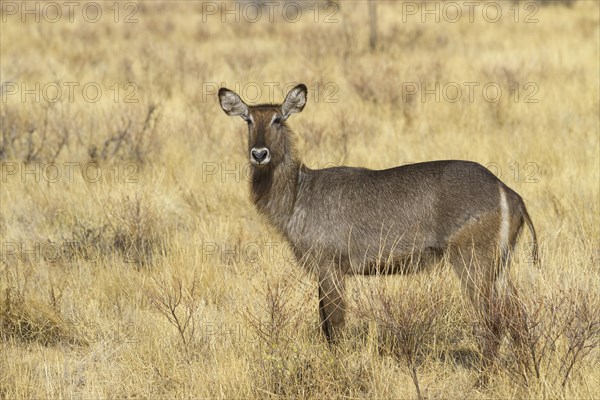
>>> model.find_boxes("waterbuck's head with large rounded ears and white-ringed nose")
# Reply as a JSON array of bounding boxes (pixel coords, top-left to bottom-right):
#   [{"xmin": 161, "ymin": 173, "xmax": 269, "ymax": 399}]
[{"xmin": 219, "ymin": 84, "xmax": 307, "ymax": 167}]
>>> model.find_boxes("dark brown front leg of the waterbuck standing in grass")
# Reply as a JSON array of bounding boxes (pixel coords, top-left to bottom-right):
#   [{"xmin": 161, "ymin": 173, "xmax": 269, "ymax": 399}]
[{"xmin": 318, "ymin": 265, "xmax": 346, "ymax": 344}]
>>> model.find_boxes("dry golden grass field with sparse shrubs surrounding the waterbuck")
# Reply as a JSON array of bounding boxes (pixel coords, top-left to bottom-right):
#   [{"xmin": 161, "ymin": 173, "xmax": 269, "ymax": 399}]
[{"xmin": 0, "ymin": 1, "xmax": 600, "ymax": 399}]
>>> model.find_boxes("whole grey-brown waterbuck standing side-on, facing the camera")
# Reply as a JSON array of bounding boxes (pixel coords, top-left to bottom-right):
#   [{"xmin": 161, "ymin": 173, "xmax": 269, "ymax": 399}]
[{"xmin": 219, "ymin": 85, "xmax": 537, "ymax": 358}]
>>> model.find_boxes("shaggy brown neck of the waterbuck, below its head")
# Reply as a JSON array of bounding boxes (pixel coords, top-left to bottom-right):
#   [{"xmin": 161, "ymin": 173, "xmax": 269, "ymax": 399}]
[{"xmin": 251, "ymin": 155, "xmax": 300, "ymax": 233}]
